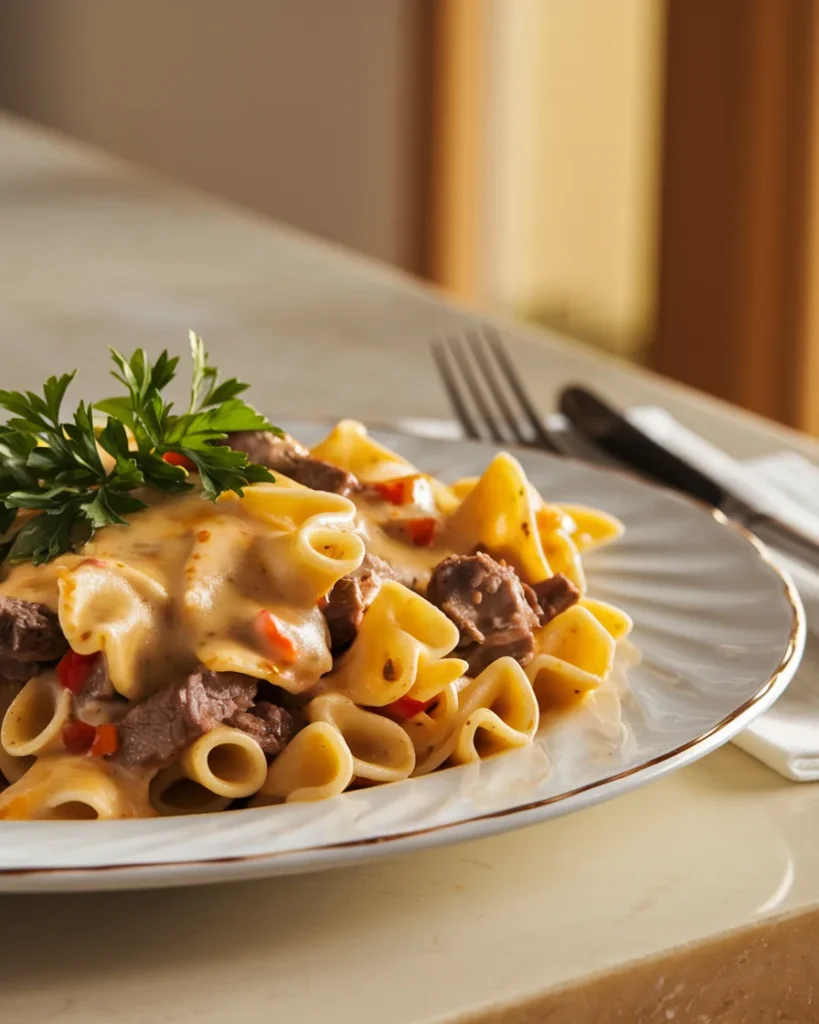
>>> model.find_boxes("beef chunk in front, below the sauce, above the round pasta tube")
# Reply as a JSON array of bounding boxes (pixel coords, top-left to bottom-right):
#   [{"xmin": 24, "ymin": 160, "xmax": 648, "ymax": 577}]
[{"xmin": 116, "ymin": 669, "xmax": 257, "ymax": 766}]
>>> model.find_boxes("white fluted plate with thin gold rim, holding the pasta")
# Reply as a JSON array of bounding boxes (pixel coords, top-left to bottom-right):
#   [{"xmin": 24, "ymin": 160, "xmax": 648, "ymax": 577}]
[{"xmin": 0, "ymin": 424, "xmax": 805, "ymax": 892}]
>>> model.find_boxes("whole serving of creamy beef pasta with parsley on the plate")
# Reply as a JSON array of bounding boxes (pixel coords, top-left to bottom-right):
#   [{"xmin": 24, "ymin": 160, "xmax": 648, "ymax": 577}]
[{"xmin": 0, "ymin": 336, "xmax": 631, "ymax": 819}]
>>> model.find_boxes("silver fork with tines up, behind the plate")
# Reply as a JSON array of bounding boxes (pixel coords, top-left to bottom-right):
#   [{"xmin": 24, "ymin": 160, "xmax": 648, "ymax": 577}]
[{"xmin": 431, "ymin": 328, "xmax": 598, "ymax": 461}]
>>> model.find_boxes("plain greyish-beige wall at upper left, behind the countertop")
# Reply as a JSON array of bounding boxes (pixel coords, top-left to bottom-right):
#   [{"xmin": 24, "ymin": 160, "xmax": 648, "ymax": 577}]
[{"xmin": 0, "ymin": 0, "xmax": 421, "ymax": 269}]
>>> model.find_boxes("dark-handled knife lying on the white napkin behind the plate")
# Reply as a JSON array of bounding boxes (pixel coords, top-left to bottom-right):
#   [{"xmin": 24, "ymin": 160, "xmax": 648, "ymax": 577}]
[{"xmin": 559, "ymin": 386, "xmax": 819, "ymax": 569}]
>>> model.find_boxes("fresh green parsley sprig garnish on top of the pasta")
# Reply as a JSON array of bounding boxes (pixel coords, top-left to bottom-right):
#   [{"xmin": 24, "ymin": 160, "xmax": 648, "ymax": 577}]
[{"xmin": 0, "ymin": 331, "xmax": 279, "ymax": 565}]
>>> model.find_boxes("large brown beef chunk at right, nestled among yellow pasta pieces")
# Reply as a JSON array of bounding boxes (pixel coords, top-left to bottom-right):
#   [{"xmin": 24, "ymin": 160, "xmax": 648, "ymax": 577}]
[{"xmin": 427, "ymin": 552, "xmax": 538, "ymax": 676}]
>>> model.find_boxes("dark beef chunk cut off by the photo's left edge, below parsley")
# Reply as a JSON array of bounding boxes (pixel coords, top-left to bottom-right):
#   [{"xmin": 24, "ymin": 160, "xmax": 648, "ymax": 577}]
[{"xmin": 0, "ymin": 595, "xmax": 69, "ymax": 680}]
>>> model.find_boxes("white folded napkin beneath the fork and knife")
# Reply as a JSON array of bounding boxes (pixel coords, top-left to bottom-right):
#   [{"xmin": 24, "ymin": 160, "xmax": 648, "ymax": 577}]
[{"xmin": 396, "ymin": 407, "xmax": 819, "ymax": 782}]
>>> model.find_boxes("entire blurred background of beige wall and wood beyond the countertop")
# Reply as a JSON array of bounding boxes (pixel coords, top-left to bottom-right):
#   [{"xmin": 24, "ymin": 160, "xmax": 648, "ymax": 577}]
[{"xmin": 0, "ymin": 0, "xmax": 819, "ymax": 433}]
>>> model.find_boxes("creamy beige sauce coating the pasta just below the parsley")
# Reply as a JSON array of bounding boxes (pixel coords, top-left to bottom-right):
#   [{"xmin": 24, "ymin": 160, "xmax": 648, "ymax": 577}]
[{"xmin": 0, "ymin": 493, "xmax": 332, "ymax": 699}]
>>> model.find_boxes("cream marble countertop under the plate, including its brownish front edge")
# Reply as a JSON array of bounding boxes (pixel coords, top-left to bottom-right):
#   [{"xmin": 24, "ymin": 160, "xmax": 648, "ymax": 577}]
[{"xmin": 0, "ymin": 117, "xmax": 819, "ymax": 1024}]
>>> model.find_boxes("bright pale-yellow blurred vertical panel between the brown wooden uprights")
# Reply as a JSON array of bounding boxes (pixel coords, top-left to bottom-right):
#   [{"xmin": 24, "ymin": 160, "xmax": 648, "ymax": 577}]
[{"xmin": 478, "ymin": 0, "xmax": 664, "ymax": 354}]
